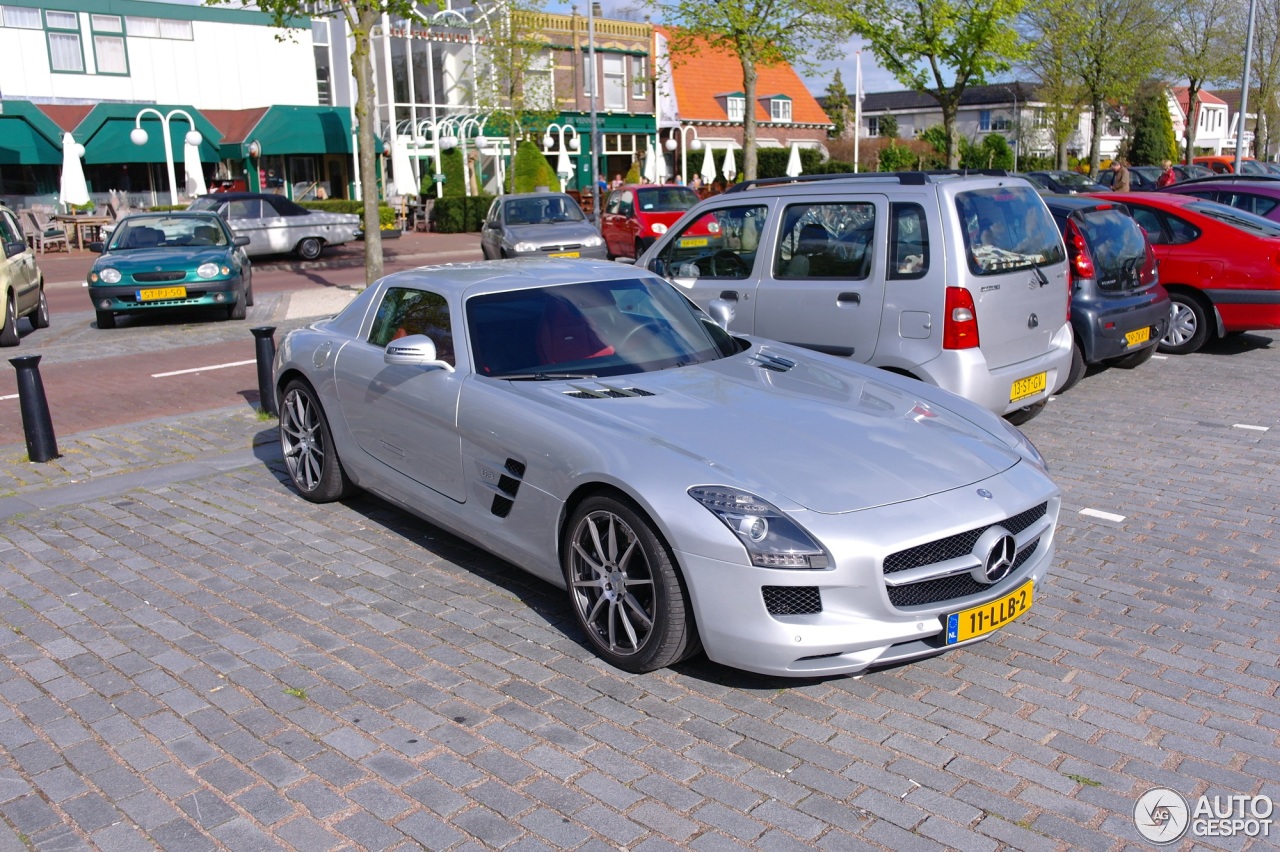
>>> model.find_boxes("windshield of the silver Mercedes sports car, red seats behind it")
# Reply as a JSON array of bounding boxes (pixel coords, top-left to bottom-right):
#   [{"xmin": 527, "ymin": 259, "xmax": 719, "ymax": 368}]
[{"xmin": 466, "ymin": 279, "xmax": 737, "ymax": 379}]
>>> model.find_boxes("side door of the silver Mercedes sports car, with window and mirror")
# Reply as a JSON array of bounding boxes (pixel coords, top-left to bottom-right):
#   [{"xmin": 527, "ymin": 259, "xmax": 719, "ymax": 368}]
[{"xmin": 334, "ymin": 287, "xmax": 466, "ymax": 503}]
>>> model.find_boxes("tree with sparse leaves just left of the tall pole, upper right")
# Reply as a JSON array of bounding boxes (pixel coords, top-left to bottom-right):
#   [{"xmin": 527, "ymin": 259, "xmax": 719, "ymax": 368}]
[{"xmin": 1169, "ymin": 0, "xmax": 1244, "ymax": 162}]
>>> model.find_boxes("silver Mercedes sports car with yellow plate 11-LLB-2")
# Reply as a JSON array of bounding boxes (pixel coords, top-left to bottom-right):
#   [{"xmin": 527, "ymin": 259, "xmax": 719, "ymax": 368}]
[{"xmin": 275, "ymin": 260, "xmax": 1060, "ymax": 677}]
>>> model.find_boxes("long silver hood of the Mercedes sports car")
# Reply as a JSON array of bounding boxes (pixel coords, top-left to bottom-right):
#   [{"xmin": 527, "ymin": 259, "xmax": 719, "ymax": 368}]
[{"xmin": 512, "ymin": 349, "xmax": 1021, "ymax": 513}]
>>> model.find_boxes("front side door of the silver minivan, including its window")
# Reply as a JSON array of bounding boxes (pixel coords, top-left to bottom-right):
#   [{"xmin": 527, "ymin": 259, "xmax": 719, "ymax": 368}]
[{"xmin": 649, "ymin": 198, "xmax": 776, "ymax": 334}]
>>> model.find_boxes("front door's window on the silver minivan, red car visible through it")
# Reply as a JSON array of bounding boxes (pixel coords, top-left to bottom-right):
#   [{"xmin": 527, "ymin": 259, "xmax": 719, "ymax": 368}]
[{"xmin": 657, "ymin": 205, "xmax": 769, "ymax": 280}]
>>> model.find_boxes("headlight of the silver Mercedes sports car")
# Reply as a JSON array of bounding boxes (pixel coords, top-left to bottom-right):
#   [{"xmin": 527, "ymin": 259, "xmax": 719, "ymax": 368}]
[{"xmin": 689, "ymin": 485, "xmax": 831, "ymax": 568}]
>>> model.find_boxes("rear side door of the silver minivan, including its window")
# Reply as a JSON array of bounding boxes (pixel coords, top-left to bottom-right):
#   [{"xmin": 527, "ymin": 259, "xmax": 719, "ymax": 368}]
[{"xmin": 754, "ymin": 194, "xmax": 888, "ymax": 362}]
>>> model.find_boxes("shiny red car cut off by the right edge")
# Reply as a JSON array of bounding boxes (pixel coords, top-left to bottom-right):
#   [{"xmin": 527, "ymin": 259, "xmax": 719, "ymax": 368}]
[{"xmin": 1098, "ymin": 192, "xmax": 1280, "ymax": 354}]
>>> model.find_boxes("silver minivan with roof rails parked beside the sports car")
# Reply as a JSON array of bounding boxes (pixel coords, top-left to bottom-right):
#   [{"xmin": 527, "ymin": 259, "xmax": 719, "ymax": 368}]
[{"xmin": 636, "ymin": 171, "xmax": 1071, "ymax": 421}]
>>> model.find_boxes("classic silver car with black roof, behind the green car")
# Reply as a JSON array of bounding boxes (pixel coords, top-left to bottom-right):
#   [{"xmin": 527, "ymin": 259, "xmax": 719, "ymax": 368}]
[{"xmin": 189, "ymin": 192, "xmax": 360, "ymax": 260}]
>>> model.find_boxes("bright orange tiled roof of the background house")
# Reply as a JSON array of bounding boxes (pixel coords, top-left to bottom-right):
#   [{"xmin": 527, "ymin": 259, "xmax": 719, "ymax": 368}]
[{"xmin": 654, "ymin": 27, "xmax": 831, "ymax": 124}]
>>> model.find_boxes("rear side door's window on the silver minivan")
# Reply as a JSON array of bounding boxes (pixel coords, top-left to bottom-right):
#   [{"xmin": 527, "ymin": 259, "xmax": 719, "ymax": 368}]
[{"xmin": 773, "ymin": 202, "xmax": 876, "ymax": 280}]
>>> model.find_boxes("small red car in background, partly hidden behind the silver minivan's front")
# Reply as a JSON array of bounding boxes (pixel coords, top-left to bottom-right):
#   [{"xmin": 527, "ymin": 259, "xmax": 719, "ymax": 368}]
[{"xmin": 600, "ymin": 184, "xmax": 719, "ymax": 260}]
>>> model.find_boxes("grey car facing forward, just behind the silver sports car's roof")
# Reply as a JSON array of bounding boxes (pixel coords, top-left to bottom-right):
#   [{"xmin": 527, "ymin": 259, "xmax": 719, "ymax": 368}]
[{"xmin": 480, "ymin": 192, "xmax": 605, "ymax": 260}]
